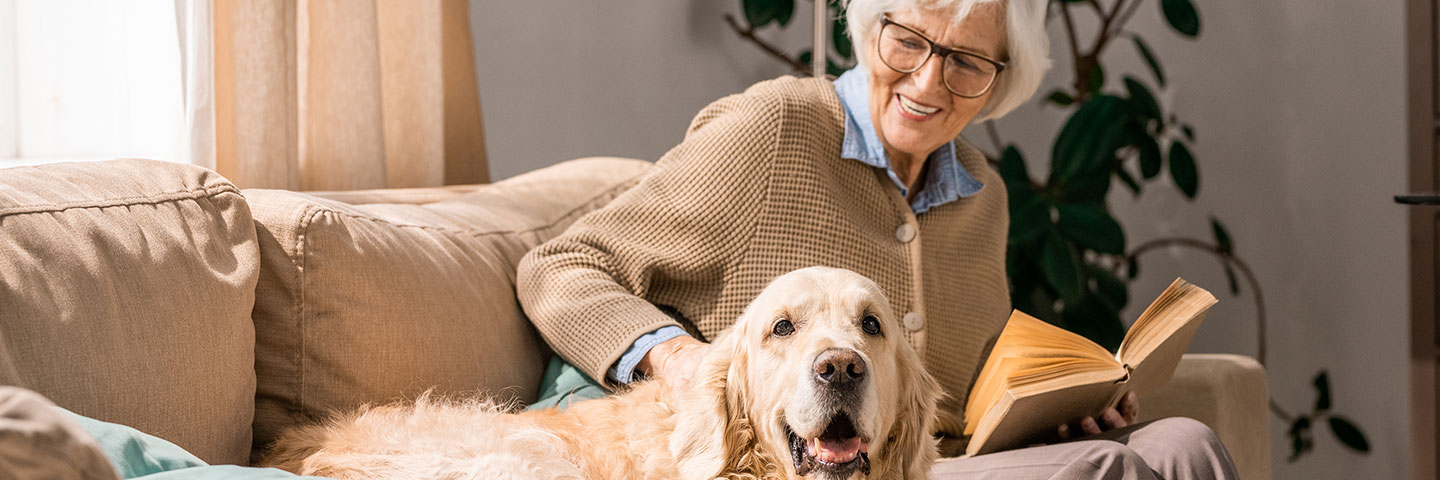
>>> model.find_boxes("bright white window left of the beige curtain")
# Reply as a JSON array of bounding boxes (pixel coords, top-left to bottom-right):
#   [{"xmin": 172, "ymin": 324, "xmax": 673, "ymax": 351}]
[{"xmin": 0, "ymin": 0, "xmax": 189, "ymax": 167}]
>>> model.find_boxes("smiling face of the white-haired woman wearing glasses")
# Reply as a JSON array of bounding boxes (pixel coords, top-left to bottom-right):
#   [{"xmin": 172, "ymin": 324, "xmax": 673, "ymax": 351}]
[{"xmin": 865, "ymin": 3, "xmax": 1005, "ymax": 161}]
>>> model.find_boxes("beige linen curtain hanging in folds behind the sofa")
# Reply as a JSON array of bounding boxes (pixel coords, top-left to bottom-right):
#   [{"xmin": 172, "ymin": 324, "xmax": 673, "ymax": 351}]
[{"xmin": 208, "ymin": 0, "xmax": 490, "ymax": 190}]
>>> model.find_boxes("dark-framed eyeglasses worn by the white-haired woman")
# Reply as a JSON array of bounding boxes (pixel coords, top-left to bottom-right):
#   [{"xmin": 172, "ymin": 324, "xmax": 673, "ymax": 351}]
[{"xmin": 876, "ymin": 16, "xmax": 1005, "ymax": 98}]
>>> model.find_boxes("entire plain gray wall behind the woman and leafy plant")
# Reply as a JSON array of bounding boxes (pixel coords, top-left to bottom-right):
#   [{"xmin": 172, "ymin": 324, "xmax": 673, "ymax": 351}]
[{"xmin": 471, "ymin": 0, "xmax": 1410, "ymax": 479}]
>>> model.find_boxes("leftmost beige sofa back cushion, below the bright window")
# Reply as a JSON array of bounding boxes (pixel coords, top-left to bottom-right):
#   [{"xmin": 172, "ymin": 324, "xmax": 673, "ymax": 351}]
[{"xmin": 0, "ymin": 160, "xmax": 259, "ymax": 463}]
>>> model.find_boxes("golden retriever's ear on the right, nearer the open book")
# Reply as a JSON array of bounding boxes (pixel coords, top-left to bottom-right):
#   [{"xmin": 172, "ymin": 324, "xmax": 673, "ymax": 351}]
[{"xmin": 877, "ymin": 345, "xmax": 945, "ymax": 480}]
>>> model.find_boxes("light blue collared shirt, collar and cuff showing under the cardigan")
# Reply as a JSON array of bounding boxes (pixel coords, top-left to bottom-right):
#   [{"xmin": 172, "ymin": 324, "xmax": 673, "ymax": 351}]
[{"xmin": 606, "ymin": 66, "xmax": 985, "ymax": 383}]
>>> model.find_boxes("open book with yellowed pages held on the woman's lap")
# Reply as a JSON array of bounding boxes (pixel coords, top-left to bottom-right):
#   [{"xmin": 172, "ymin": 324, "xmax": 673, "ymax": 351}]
[{"xmin": 965, "ymin": 278, "xmax": 1215, "ymax": 455}]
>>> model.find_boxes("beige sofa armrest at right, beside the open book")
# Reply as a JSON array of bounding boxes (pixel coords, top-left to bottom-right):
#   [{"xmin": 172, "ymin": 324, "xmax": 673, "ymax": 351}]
[{"xmin": 1140, "ymin": 353, "xmax": 1270, "ymax": 480}]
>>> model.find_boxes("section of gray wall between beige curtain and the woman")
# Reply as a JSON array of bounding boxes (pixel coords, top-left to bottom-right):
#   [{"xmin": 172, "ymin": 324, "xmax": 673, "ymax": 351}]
[{"xmin": 471, "ymin": 0, "xmax": 811, "ymax": 180}]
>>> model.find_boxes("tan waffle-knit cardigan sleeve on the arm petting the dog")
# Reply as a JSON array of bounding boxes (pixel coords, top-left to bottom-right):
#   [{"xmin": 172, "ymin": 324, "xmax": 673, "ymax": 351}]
[{"xmin": 516, "ymin": 79, "xmax": 785, "ymax": 383}]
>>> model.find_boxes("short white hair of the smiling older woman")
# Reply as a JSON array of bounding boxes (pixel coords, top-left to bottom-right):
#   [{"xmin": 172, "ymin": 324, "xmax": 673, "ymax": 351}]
[{"xmin": 845, "ymin": 0, "xmax": 1050, "ymax": 121}]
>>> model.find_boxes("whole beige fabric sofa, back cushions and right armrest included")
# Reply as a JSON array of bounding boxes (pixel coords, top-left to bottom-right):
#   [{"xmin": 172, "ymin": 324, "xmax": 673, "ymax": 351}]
[{"xmin": 0, "ymin": 157, "xmax": 1270, "ymax": 479}]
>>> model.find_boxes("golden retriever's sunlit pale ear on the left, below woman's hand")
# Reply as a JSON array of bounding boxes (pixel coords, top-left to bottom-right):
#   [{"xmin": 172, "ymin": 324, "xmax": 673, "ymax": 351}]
[{"xmin": 670, "ymin": 333, "xmax": 755, "ymax": 480}]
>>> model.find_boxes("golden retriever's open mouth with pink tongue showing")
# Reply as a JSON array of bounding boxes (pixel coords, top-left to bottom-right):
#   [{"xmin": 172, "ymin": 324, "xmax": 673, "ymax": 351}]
[{"xmin": 785, "ymin": 412, "xmax": 870, "ymax": 479}]
